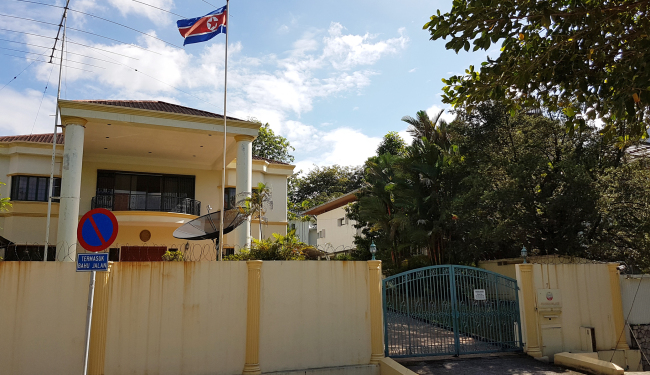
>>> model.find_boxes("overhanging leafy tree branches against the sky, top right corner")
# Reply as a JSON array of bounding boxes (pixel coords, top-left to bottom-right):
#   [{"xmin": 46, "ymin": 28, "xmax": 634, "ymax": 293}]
[{"xmin": 424, "ymin": 0, "xmax": 650, "ymax": 137}]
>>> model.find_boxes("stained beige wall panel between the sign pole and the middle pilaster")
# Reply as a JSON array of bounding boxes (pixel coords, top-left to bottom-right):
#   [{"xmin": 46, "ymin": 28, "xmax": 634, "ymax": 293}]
[{"xmin": 105, "ymin": 262, "xmax": 247, "ymax": 374}]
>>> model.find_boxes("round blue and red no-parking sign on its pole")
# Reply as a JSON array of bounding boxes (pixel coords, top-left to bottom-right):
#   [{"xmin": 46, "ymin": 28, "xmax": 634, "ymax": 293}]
[{"xmin": 77, "ymin": 208, "xmax": 118, "ymax": 375}]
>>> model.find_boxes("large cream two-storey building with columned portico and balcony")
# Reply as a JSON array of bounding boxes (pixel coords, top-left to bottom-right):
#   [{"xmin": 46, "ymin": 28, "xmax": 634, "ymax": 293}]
[{"xmin": 0, "ymin": 100, "xmax": 294, "ymax": 261}]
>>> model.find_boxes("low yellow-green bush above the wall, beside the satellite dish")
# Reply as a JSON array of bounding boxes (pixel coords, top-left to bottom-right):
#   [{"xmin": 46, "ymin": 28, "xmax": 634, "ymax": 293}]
[{"xmin": 224, "ymin": 230, "xmax": 316, "ymax": 260}]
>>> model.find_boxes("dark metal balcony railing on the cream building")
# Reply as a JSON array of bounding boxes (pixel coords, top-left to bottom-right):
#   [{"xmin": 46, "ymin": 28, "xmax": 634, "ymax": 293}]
[{"xmin": 91, "ymin": 194, "xmax": 201, "ymax": 216}]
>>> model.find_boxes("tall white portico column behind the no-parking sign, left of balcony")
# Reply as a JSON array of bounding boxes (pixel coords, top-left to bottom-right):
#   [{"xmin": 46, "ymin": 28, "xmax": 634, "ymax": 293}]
[{"xmin": 56, "ymin": 117, "xmax": 87, "ymax": 262}]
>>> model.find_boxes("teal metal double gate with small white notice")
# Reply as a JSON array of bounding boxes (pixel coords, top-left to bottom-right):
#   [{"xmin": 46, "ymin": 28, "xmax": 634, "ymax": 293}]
[{"xmin": 382, "ymin": 265, "xmax": 523, "ymax": 357}]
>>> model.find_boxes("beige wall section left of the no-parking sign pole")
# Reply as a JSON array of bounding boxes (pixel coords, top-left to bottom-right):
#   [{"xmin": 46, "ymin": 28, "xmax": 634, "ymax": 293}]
[{"xmin": 0, "ymin": 262, "xmax": 89, "ymax": 375}]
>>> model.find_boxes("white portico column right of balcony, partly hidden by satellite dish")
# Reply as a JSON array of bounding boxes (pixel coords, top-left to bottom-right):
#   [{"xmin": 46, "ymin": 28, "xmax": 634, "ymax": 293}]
[{"xmin": 235, "ymin": 135, "xmax": 255, "ymax": 248}]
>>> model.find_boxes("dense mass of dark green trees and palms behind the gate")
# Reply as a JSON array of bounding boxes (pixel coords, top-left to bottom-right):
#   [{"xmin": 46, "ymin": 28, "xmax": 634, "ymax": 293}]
[{"xmin": 347, "ymin": 103, "xmax": 650, "ymax": 273}]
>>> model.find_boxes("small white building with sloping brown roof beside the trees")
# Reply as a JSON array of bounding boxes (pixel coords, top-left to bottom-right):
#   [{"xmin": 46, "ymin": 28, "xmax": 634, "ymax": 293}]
[{"xmin": 301, "ymin": 190, "xmax": 361, "ymax": 253}]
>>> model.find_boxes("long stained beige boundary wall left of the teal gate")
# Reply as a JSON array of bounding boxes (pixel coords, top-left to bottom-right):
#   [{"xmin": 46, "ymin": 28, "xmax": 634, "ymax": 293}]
[{"xmin": 0, "ymin": 261, "xmax": 383, "ymax": 375}]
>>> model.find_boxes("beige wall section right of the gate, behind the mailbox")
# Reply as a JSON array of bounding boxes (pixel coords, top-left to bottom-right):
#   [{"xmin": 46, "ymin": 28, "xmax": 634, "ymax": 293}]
[{"xmin": 516, "ymin": 264, "xmax": 617, "ymax": 356}]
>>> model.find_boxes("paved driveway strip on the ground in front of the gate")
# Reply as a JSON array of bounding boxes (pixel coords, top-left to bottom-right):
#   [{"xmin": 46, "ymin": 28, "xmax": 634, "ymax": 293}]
[{"xmin": 398, "ymin": 354, "xmax": 582, "ymax": 375}]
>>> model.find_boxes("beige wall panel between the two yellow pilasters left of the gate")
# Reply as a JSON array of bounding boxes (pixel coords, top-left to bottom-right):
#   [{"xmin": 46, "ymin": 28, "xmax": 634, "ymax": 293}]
[{"xmin": 260, "ymin": 261, "xmax": 371, "ymax": 372}]
